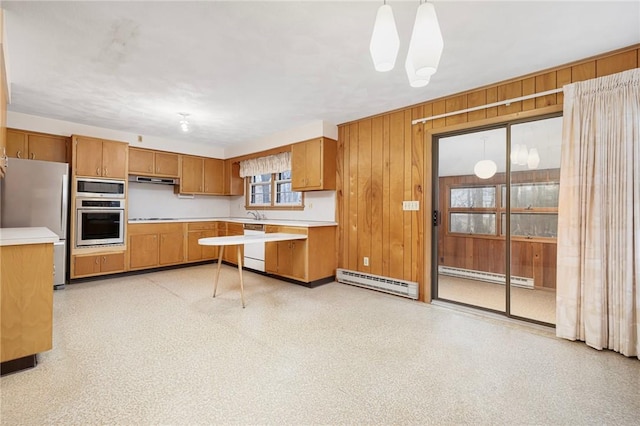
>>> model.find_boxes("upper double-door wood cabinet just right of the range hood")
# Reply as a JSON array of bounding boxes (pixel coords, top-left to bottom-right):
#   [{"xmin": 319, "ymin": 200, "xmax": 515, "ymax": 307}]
[{"xmin": 178, "ymin": 155, "xmax": 224, "ymax": 195}]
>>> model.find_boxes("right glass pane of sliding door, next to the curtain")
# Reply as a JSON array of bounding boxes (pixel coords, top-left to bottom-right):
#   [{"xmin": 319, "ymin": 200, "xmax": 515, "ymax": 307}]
[{"xmin": 510, "ymin": 117, "xmax": 562, "ymax": 324}]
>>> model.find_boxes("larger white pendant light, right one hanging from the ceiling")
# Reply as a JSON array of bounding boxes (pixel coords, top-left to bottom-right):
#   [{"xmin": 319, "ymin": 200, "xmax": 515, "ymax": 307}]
[{"xmin": 408, "ymin": 3, "xmax": 444, "ymax": 77}]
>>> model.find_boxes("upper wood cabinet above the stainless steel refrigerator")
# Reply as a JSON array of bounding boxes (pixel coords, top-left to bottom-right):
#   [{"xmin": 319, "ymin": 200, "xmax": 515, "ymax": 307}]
[{"xmin": 7, "ymin": 129, "xmax": 69, "ymax": 163}]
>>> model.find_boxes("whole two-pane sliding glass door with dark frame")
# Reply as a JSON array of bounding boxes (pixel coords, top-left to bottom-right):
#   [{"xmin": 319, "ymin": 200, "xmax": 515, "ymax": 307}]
[{"xmin": 433, "ymin": 117, "xmax": 561, "ymax": 324}]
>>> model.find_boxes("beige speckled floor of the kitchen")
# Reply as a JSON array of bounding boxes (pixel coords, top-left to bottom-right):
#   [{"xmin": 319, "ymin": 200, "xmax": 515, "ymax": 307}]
[{"xmin": 0, "ymin": 265, "xmax": 640, "ymax": 425}]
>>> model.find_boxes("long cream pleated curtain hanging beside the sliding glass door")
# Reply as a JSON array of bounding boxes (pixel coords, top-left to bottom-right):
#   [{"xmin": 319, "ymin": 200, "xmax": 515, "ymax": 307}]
[{"xmin": 556, "ymin": 69, "xmax": 640, "ymax": 357}]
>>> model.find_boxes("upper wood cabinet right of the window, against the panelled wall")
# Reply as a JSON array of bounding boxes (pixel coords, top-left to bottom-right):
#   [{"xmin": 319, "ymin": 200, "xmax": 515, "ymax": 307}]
[{"xmin": 291, "ymin": 138, "xmax": 337, "ymax": 191}]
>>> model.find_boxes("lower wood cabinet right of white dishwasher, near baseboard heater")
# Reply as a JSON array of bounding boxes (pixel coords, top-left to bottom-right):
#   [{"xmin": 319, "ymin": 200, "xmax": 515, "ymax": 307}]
[{"xmin": 265, "ymin": 225, "xmax": 337, "ymax": 282}]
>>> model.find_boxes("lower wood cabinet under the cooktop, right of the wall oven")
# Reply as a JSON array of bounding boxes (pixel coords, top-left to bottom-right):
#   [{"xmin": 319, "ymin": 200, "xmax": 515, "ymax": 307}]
[{"xmin": 128, "ymin": 223, "xmax": 184, "ymax": 270}]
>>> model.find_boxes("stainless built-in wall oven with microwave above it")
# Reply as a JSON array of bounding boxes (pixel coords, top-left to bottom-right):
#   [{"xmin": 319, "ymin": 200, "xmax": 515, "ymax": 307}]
[{"xmin": 75, "ymin": 178, "xmax": 126, "ymax": 247}]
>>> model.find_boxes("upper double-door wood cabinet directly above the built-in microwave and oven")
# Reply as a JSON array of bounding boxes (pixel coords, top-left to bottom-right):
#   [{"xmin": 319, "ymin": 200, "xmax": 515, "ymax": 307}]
[{"xmin": 73, "ymin": 135, "xmax": 128, "ymax": 179}]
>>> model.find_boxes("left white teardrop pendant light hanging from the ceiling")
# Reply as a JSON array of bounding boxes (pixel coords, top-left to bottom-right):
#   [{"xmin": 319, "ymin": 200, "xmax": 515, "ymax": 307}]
[{"xmin": 369, "ymin": 4, "xmax": 400, "ymax": 72}]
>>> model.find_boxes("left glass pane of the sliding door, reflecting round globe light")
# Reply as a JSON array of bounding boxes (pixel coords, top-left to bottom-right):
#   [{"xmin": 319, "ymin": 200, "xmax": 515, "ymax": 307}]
[{"xmin": 435, "ymin": 128, "xmax": 507, "ymax": 312}]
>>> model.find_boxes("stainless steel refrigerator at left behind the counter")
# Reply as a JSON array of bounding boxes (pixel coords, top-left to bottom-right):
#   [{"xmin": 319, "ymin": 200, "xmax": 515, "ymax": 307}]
[{"xmin": 0, "ymin": 158, "xmax": 69, "ymax": 287}]
